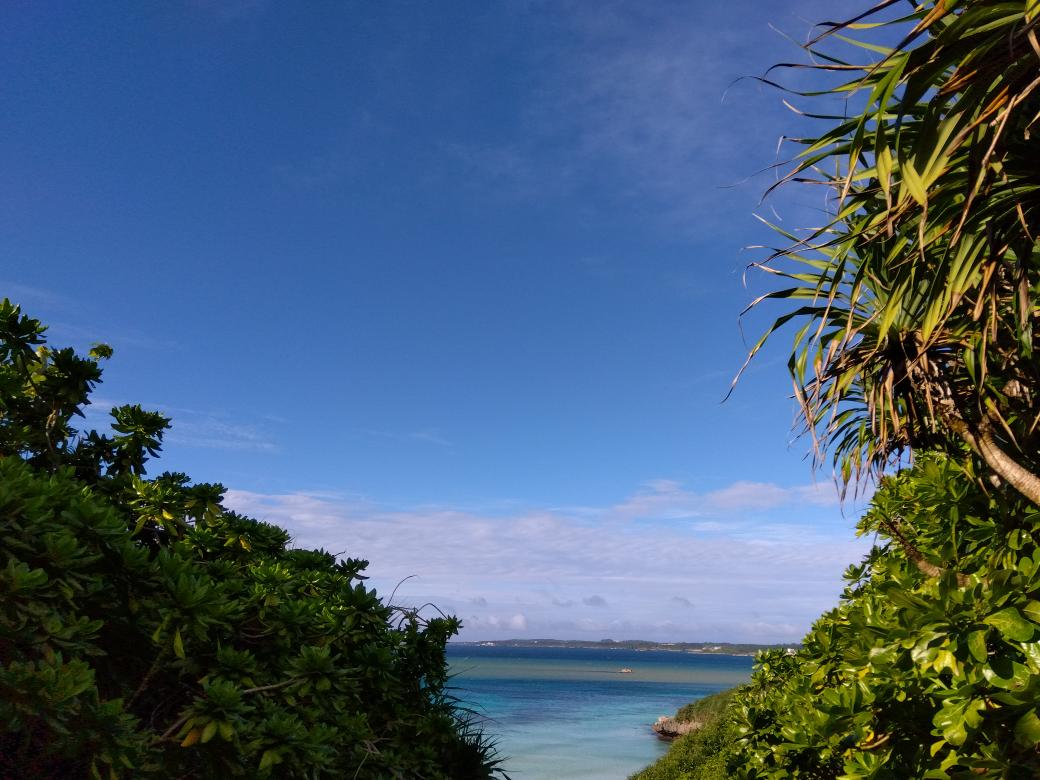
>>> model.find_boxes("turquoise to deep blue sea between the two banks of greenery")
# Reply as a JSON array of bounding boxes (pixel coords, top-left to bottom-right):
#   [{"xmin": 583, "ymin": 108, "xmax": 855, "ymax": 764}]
[{"xmin": 448, "ymin": 644, "xmax": 752, "ymax": 780}]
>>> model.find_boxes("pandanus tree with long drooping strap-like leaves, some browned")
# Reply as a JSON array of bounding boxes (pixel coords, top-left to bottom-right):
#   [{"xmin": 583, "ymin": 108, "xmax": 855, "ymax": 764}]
[{"xmin": 749, "ymin": 0, "xmax": 1040, "ymax": 504}]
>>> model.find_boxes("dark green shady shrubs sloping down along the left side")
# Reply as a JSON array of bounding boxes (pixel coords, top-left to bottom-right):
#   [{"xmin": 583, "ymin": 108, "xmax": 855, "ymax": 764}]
[{"xmin": 0, "ymin": 300, "xmax": 503, "ymax": 779}]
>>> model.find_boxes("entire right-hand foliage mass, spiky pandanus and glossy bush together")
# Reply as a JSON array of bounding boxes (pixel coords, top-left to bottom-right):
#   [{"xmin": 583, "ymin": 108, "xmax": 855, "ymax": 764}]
[{"xmin": 646, "ymin": 0, "xmax": 1040, "ymax": 780}]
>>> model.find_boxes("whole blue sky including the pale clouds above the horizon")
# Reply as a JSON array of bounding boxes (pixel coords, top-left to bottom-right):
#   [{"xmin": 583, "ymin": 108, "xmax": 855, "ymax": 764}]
[{"xmin": 0, "ymin": 0, "xmax": 868, "ymax": 642}]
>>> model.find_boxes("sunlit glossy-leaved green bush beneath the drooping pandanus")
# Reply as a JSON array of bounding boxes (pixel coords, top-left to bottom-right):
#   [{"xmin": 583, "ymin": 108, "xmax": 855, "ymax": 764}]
[{"xmin": 730, "ymin": 456, "xmax": 1040, "ymax": 778}]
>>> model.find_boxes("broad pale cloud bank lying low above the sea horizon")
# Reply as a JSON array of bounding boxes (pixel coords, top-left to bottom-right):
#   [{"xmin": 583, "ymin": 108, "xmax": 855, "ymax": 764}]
[{"xmin": 228, "ymin": 482, "xmax": 868, "ymax": 641}]
